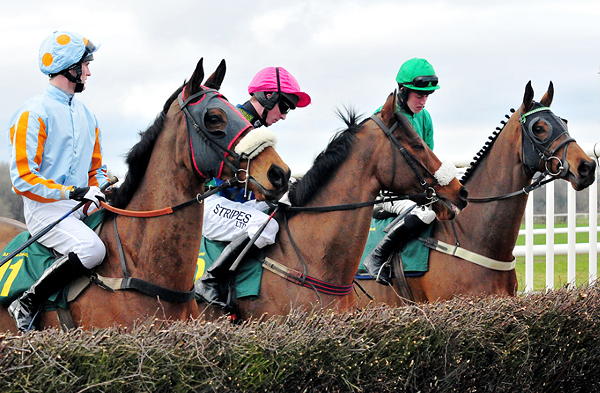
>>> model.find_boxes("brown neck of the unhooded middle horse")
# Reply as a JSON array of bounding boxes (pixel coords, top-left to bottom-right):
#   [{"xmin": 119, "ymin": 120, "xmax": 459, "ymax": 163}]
[{"xmin": 270, "ymin": 142, "xmax": 380, "ymax": 285}]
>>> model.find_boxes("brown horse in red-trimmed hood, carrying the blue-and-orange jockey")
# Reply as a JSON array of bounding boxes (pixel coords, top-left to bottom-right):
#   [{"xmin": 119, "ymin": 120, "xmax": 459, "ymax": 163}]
[{"xmin": 0, "ymin": 59, "xmax": 290, "ymax": 330}]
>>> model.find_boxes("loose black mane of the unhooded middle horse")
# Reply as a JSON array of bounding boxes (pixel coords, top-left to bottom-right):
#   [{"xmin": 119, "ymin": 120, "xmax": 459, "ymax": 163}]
[{"xmin": 289, "ymin": 108, "xmax": 362, "ymax": 206}]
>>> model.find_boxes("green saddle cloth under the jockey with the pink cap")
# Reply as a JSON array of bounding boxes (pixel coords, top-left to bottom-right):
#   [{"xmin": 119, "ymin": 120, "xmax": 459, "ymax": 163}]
[{"xmin": 194, "ymin": 237, "xmax": 263, "ymax": 299}]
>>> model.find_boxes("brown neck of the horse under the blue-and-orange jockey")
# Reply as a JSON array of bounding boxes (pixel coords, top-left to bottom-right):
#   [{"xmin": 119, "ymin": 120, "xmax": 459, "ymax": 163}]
[{"xmin": 106, "ymin": 112, "xmax": 203, "ymax": 291}]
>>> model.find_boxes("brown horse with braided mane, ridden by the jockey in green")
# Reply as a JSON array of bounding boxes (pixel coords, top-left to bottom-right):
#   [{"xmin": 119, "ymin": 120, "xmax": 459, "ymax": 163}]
[{"xmin": 361, "ymin": 83, "xmax": 596, "ymax": 305}]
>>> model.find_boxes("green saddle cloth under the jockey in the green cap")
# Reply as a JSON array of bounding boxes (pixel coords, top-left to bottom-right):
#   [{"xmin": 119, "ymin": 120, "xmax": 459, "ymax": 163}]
[{"xmin": 358, "ymin": 217, "xmax": 433, "ymax": 276}]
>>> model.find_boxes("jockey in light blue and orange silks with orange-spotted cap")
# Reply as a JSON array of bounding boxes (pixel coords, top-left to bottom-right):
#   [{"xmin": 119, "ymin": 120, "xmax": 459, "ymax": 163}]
[{"xmin": 8, "ymin": 31, "xmax": 108, "ymax": 331}]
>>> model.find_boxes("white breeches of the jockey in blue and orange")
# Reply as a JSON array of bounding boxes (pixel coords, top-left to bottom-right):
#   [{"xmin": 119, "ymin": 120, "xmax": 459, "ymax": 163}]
[{"xmin": 23, "ymin": 198, "xmax": 106, "ymax": 269}]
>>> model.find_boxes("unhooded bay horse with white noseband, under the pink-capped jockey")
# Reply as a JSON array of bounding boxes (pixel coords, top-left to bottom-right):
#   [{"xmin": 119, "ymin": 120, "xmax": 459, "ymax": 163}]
[{"xmin": 201, "ymin": 90, "xmax": 467, "ymax": 319}]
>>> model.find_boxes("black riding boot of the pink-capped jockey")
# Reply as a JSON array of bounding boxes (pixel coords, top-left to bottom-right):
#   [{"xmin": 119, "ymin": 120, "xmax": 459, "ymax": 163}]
[{"xmin": 194, "ymin": 235, "xmax": 250, "ymax": 309}]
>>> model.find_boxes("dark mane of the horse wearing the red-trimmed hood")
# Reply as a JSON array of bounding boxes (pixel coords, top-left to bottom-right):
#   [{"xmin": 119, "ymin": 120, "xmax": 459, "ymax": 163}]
[{"xmin": 110, "ymin": 83, "xmax": 185, "ymax": 209}]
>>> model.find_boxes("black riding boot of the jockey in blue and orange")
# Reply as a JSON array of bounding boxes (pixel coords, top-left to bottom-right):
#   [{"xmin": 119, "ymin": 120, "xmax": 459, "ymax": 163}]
[{"xmin": 8, "ymin": 252, "xmax": 89, "ymax": 332}]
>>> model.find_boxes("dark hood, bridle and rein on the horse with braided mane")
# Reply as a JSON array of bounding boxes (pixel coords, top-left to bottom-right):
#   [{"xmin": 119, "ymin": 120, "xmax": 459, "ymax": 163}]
[{"xmin": 467, "ymin": 106, "xmax": 575, "ymax": 203}]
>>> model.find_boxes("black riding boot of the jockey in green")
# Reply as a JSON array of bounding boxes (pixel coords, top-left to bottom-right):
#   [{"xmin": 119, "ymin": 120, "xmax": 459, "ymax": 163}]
[{"xmin": 363, "ymin": 214, "xmax": 428, "ymax": 285}]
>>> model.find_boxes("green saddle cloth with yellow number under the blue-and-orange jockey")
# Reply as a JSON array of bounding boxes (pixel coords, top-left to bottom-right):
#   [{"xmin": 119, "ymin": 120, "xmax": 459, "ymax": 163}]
[{"xmin": 0, "ymin": 210, "xmax": 104, "ymax": 309}]
